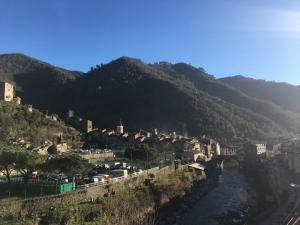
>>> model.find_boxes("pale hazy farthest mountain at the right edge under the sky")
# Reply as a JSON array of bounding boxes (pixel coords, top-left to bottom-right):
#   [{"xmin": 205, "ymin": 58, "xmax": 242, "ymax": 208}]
[{"xmin": 220, "ymin": 75, "xmax": 300, "ymax": 113}]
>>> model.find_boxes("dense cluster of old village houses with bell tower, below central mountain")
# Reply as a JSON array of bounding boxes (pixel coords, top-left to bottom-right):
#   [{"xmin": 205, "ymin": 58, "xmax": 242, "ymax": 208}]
[{"xmin": 67, "ymin": 110, "xmax": 221, "ymax": 161}]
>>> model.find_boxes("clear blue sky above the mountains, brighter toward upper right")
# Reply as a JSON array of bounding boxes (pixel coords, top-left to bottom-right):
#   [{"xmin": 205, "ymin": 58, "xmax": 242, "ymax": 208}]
[{"xmin": 0, "ymin": 0, "xmax": 300, "ymax": 85}]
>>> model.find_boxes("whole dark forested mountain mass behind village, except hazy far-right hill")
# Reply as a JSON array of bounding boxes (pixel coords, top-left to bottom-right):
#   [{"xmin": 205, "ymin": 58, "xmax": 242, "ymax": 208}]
[{"xmin": 0, "ymin": 55, "xmax": 300, "ymax": 142}]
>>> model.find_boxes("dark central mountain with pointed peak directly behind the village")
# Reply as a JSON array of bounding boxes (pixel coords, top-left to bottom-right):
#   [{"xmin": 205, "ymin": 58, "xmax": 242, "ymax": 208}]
[{"xmin": 60, "ymin": 57, "xmax": 296, "ymax": 142}]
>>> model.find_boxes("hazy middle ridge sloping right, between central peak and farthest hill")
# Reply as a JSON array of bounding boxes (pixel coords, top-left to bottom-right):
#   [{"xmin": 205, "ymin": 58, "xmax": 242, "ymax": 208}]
[{"xmin": 152, "ymin": 63, "xmax": 300, "ymax": 130}]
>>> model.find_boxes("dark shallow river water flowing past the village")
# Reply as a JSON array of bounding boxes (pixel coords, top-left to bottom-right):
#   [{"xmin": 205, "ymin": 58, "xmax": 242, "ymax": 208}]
[{"xmin": 176, "ymin": 170, "xmax": 248, "ymax": 225}]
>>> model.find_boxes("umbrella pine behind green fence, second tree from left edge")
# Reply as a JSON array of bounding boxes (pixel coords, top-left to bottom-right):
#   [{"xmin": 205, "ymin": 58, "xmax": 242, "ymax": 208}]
[{"xmin": 15, "ymin": 151, "xmax": 44, "ymax": 182}]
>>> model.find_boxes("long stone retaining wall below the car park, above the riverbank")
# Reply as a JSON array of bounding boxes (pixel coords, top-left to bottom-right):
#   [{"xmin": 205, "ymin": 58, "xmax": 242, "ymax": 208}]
[{"xmin": 0, "ymin": 167, "xmax": 180, "ymax": 217}]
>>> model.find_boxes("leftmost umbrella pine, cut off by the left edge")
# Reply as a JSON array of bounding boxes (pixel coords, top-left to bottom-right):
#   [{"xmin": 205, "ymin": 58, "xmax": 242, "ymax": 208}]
[{"xmin": 0, "ymin": 151, "xmax": 16, "ymax": 183}]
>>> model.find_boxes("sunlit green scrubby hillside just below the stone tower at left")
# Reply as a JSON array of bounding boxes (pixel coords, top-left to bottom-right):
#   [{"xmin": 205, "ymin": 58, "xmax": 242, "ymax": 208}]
[{"xmin": 0, "ymin": 101, "xmax": 81, "ymax": 148}]
